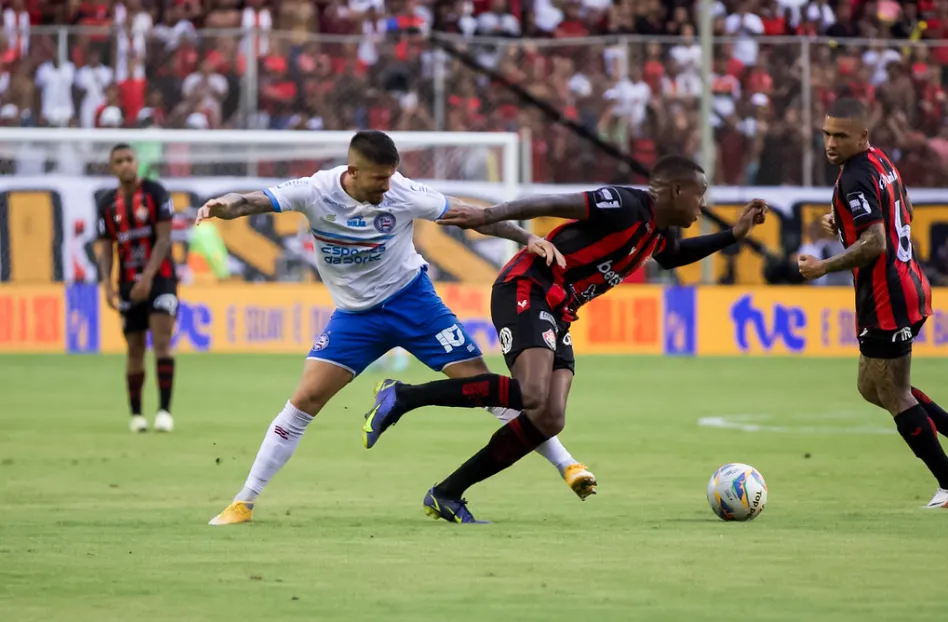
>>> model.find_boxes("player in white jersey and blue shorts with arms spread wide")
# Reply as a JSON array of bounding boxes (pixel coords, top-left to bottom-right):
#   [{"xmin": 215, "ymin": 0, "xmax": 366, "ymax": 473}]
[{"xmin": 195, "ymin": 131, "xmax": 597, "ymax": 525}]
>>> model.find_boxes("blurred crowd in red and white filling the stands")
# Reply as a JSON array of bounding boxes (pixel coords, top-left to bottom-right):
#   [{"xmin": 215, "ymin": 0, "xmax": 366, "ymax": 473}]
[{"xmin": 0, "ymin": 0, "xmax": 948, "ymax": 187}]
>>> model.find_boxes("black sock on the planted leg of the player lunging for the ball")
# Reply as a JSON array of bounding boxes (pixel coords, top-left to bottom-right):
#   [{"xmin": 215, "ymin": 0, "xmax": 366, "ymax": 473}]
[{"xmin": 435, "ymin": 413, "xmax": 548, "ymax": 499}]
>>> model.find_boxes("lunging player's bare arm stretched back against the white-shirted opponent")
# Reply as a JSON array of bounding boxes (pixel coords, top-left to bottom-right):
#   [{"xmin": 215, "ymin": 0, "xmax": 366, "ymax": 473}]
[{"xmin": 438, "ymin": 193, "xmax": 587, "ymax": 229}]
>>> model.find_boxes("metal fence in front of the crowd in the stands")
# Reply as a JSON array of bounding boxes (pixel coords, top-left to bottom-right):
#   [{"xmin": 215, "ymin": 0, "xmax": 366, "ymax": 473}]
[{"xmin": 7, "ymin": 27, "xmax": 948, "ymax": 187}]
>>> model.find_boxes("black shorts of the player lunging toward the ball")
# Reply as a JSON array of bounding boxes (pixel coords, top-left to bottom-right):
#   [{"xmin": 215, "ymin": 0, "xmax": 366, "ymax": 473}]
[{"xmin": 490, "ymin": 278, "xmax": 576, "ymax": 373}]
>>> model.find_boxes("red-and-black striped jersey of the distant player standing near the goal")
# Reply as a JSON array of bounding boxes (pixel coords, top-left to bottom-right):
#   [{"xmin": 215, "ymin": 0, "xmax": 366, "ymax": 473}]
[{"xmin": 98, "ymin": 179, "xmax": 175, "ymax": 283}]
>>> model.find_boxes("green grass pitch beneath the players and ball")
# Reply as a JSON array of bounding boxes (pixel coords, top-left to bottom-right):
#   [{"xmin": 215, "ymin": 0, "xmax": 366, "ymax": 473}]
[{"xmin": 0, "ymin": 355, "xmax": 948, "ymax": 622}]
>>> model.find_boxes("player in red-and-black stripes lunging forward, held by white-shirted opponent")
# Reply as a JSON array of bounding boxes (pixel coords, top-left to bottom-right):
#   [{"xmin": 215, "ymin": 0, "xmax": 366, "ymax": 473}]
[{"xmin": 368, "ymin": 156, "xmax": 767, "ymax": 522}]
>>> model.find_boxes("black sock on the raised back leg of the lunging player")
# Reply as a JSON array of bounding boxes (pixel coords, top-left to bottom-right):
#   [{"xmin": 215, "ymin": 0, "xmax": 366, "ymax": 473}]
[{"xmin": 395, "ymin": 374, "xmax": 523, "ymax": 412}]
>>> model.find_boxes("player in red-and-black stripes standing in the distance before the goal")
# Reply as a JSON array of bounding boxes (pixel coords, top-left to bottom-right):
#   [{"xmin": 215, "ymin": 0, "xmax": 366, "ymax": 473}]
[{"xmin": 98, "ymin": 144, "xmax": 178, "ymax": 432}]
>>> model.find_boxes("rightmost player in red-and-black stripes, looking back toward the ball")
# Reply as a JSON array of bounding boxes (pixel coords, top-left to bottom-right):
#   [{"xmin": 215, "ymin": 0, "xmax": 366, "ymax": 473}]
[{"xmin": 798, "ymin": 98, "xmax": 948, "ymax": 508}]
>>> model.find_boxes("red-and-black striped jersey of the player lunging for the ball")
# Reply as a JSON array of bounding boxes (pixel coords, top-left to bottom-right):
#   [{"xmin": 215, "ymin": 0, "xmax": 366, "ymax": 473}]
[{"xmin": 497, "ymin": 186, "xmax": 675, "ymax": 322}]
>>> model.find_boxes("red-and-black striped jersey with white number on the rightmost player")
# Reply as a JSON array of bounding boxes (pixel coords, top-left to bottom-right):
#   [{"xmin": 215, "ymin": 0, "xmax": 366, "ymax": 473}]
[{"xmin": 833, "ymin": 147, "xmax": 932, "ymax": 330}]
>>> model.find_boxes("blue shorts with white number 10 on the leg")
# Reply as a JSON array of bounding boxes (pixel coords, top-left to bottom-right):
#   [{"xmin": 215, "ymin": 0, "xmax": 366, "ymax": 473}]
[{"xmin": 307, "ymin": 270, "xmax": 481, "ymax": 376}]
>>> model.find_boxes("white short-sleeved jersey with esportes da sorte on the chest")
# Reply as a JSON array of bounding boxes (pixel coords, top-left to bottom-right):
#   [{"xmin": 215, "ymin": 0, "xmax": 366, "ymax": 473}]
[{"xmin": 264, "ymin": 166, "xmax": 448, "ymax": 311}]
